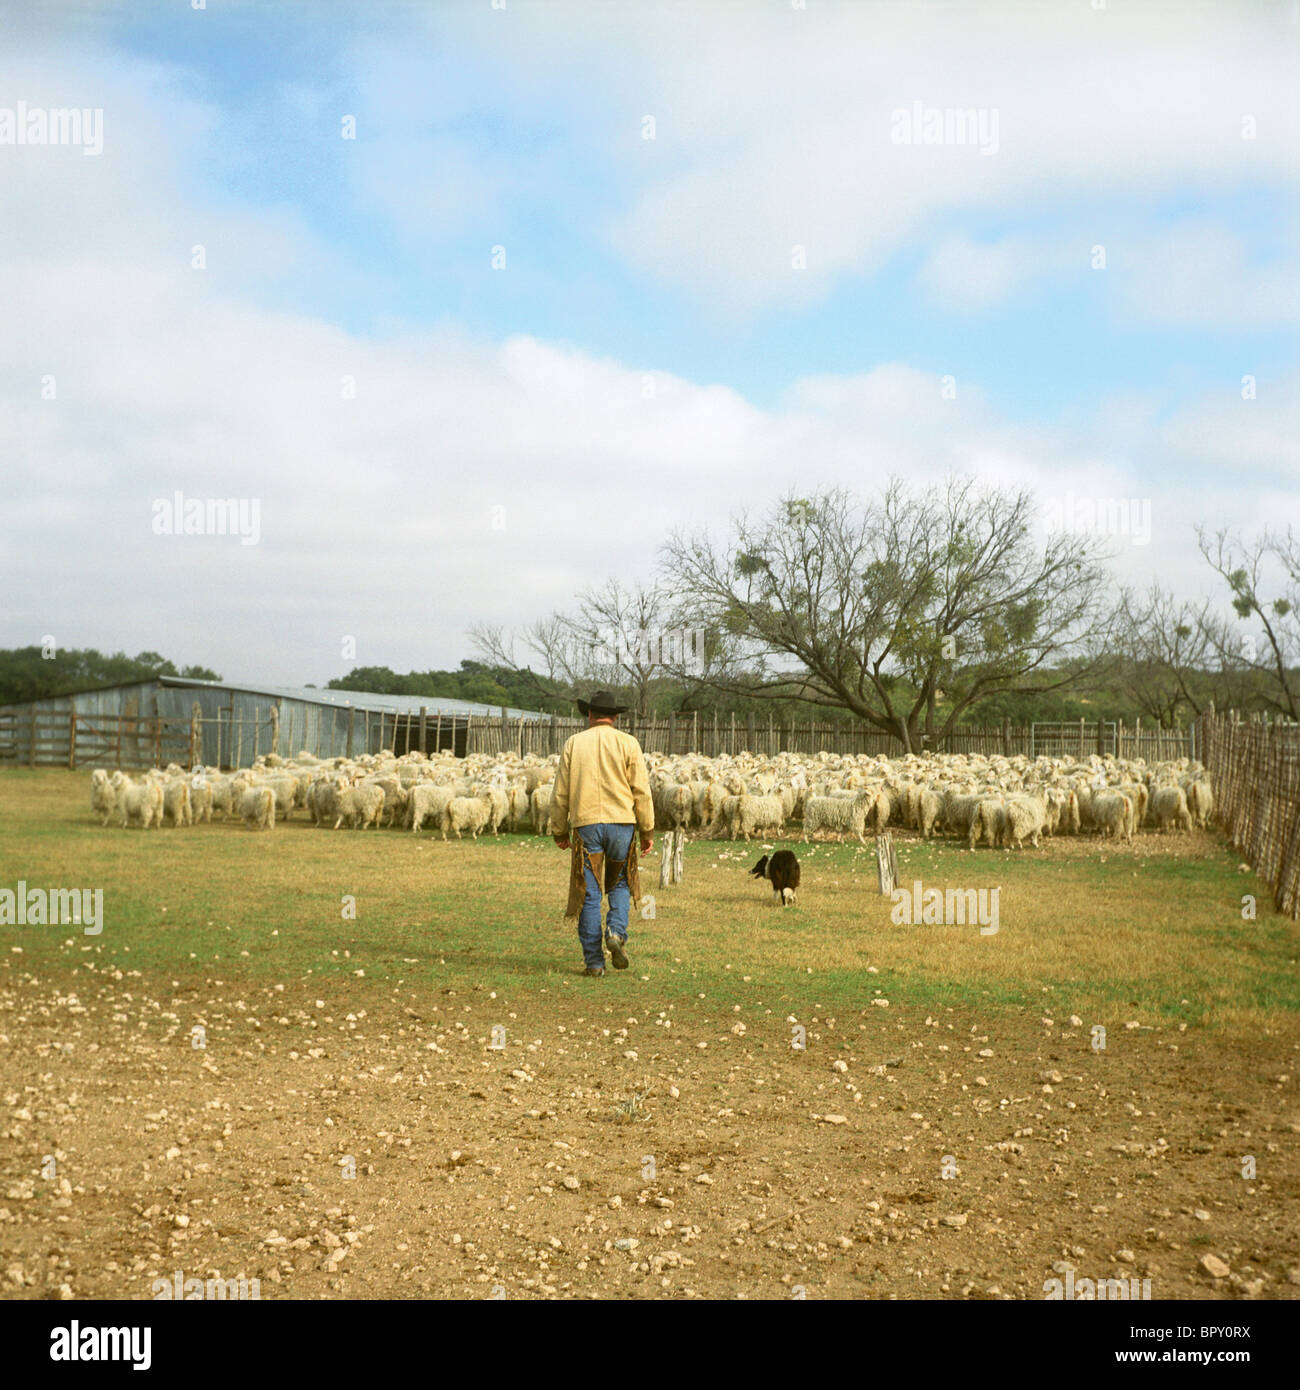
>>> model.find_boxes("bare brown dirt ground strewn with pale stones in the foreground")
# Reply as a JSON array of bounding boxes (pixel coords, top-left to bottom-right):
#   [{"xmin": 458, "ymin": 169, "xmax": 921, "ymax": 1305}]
[{"xmin": 0, "ymin": 945, "xmax": 1300, "ymax": 1298}]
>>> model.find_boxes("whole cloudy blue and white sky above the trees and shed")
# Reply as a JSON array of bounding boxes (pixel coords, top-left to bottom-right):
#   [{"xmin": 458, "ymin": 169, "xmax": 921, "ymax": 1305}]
[{"xmin": 0, "ymin": 0, "xmax": 1300, "ymax": 684}]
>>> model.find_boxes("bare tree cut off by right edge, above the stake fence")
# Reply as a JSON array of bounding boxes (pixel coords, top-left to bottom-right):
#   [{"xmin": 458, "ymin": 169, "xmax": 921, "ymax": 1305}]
[{"xmin": 1196, "ymin": 527, "xmax": 1300, "ymax": 720}]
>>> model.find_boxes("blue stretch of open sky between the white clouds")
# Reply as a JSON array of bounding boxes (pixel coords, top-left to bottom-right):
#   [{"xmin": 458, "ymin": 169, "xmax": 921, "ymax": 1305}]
[{"xmin": 73, "ymin": 0, "xmax": 1296, "ymax": 405}]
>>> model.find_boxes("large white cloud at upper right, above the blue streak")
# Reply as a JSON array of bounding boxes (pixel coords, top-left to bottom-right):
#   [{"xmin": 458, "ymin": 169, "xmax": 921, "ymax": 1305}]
[{"xmin": 547, "ymin": 6, "xmax": 1300, "ymax": 313}]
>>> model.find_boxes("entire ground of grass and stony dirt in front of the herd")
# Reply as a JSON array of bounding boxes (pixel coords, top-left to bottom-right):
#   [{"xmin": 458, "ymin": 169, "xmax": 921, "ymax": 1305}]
[{"xmin": 0, "ymin": 770, "xmax": 1300, "ymax": 1297}]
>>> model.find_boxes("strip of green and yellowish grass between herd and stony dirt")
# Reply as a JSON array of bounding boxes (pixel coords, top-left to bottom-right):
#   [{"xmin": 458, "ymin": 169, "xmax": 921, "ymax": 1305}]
[{"xmin": 0, "ymin": 769, "xmax": 1300, "ymax": 1027}]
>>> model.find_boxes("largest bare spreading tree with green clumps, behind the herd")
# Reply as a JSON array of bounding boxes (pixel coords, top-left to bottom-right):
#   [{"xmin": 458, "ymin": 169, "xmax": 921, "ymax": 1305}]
[{"xmin": 663, "ymin": 480, "xmax": 1104, "ymax": 751}]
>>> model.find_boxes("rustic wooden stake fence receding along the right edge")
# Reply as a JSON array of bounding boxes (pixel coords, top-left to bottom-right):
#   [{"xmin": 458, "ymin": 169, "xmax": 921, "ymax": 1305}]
[{"xmin": 1197, "ymin": 714, "xmax": 1300, "ymax": 919}]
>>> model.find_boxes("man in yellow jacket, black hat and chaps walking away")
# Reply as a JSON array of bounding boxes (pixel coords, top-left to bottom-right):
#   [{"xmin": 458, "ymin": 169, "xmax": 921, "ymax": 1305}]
[{"xmin": 551, "ymin": 691, "xmax": 655, "ymax": 976}]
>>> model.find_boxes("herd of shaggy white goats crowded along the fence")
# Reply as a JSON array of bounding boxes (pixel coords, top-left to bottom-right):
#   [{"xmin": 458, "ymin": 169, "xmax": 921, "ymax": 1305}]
[{"xmin": 90, "ymin": 752, "xmax": 1214, "ymax": 848}]
